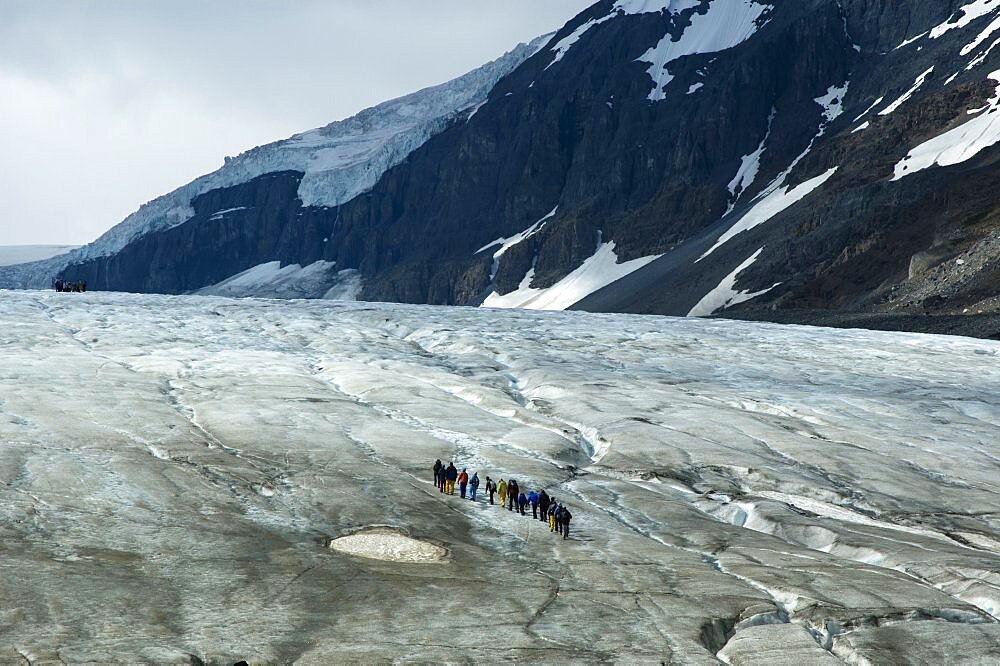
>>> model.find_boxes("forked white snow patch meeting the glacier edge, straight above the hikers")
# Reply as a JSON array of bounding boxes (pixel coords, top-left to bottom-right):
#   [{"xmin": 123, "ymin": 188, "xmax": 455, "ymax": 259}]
[{"xmin": 482, "ymin": 241, "xmax": 663, "ymax": 310}]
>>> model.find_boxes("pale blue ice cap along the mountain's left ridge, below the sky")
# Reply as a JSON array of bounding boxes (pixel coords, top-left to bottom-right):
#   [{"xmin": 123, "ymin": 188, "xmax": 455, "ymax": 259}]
[{"xmin": 0, "ymin": 35, "xmax": 551, "ymax": 286}]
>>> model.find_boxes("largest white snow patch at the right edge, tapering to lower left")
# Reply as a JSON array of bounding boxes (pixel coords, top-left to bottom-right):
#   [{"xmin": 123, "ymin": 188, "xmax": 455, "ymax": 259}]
[{"xmin": 892, "ymin": 70, "xmax": 1000, "ymax": 180}]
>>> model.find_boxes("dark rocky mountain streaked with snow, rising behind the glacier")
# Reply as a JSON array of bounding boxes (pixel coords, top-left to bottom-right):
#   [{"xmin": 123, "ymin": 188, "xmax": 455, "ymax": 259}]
[{"xmin": 7, "ymin": 0, "xmax": 1000, "ymax": 330}]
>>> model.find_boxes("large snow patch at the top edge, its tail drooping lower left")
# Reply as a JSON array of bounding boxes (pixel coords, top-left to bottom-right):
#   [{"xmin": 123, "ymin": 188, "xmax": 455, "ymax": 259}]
[{"xmin": 636, "ymin": 0, "xmax": 771, "ymax": 102}]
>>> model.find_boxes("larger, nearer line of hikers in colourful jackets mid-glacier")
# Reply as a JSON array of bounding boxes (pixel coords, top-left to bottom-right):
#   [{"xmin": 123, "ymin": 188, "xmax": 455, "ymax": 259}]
[{"xmin": 434, "ymin": 459, "xmax": 573, "ymax": 539}]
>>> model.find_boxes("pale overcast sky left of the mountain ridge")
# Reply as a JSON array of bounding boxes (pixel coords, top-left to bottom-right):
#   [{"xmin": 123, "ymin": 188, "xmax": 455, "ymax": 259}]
[{"xmin": 0, "ymin": 0, "xmax": 594, "ymax": 245}]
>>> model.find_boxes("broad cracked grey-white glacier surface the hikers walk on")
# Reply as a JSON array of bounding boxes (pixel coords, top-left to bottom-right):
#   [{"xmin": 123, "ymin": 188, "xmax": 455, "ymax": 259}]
[{"xmin": 0, "ymin": 292, "xmax": 1000, "ymax": 664}]
